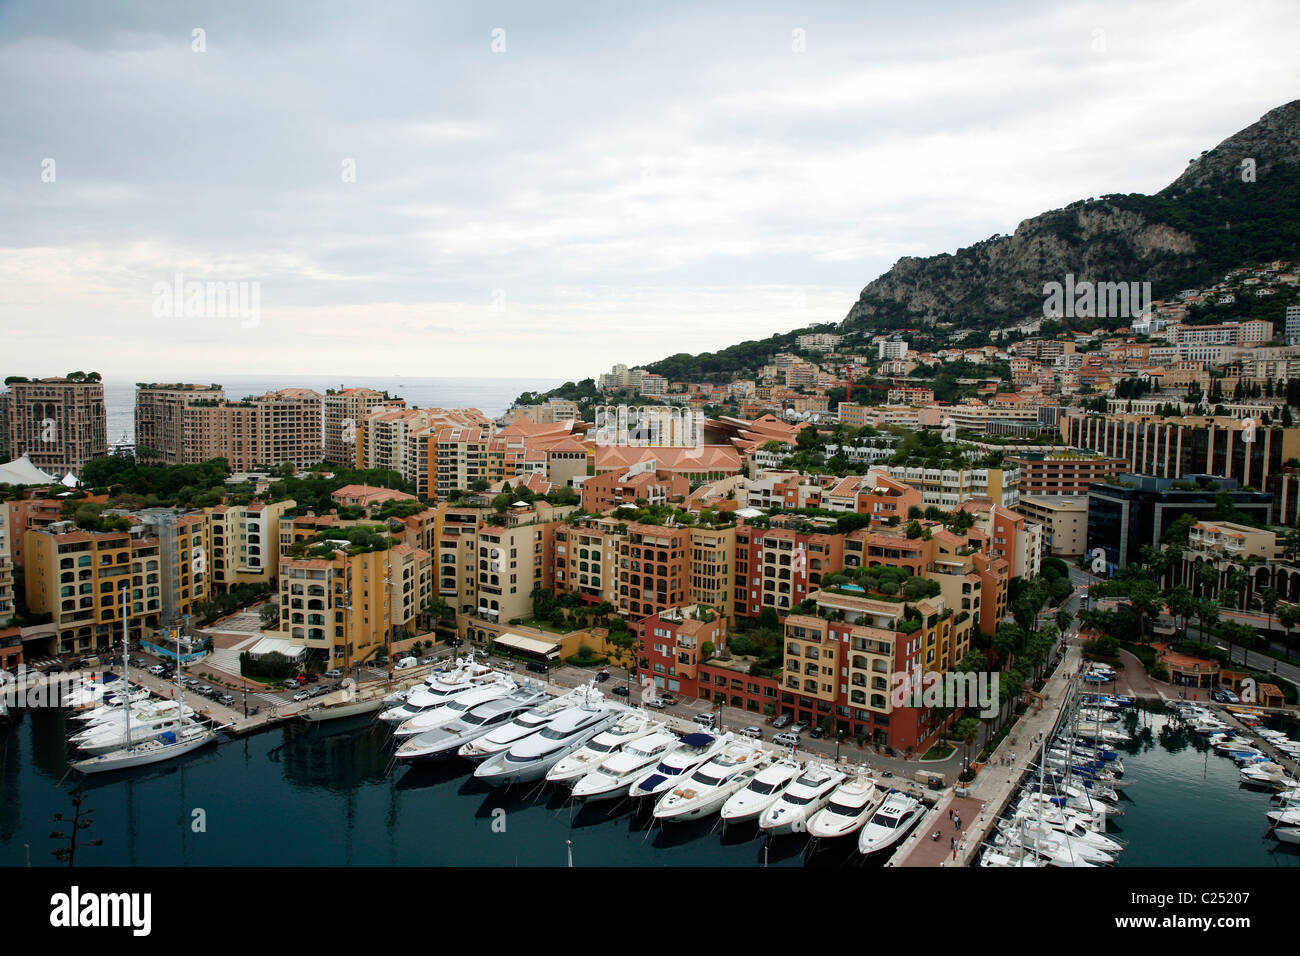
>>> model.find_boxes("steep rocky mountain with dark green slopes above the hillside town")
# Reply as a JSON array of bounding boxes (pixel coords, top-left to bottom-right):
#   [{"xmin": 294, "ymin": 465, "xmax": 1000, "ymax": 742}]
[{"xmin": 841, "ymin": 100, "xmax": 1300, "ymax": 330}]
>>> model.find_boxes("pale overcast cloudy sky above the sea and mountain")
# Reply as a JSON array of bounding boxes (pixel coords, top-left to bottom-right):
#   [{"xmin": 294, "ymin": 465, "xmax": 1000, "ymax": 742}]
[{"xmin": 0, "ymin": 0, "xmax": 1300, "ymax": 381}]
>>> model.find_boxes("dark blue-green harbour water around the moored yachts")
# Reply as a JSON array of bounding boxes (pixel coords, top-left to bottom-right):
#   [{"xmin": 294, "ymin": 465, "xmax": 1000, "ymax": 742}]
[{"xmin": 0, "ymin": 709, "xmax": 1300, "ymax": 866}]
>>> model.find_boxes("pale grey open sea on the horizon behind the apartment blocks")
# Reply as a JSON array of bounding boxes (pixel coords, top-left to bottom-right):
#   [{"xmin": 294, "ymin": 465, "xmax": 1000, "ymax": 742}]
[{"xmin": 104, "ymin": 373, "xmax": 564, "ymax": 444}]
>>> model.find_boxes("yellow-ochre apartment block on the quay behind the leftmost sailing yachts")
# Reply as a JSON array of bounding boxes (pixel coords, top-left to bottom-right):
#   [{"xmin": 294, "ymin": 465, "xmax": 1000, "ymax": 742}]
[{"xmin": 23, "ymin": 509, "xmax": 212, "ymax": 654}]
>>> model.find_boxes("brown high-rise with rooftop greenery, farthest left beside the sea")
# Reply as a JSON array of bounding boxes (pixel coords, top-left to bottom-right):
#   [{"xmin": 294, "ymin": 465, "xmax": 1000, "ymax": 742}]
[{"xmin": 4, "ymin": 375, "xmax": 108, "ymax": 477}]
